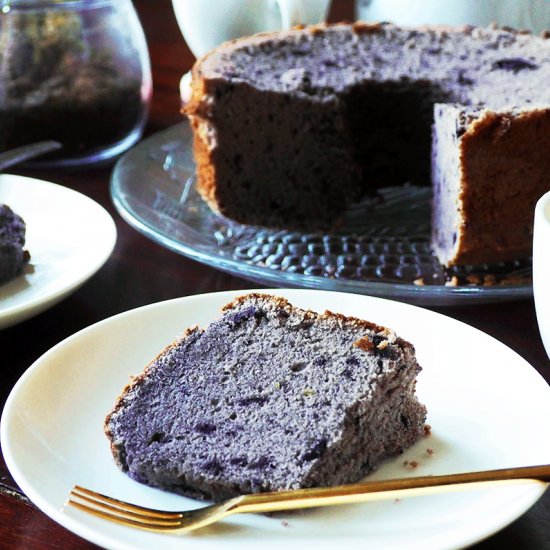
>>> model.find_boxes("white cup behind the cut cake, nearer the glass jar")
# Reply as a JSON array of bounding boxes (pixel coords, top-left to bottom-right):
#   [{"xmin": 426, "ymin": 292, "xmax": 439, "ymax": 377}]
[{"xmin": 172, "ymin": 0, "xmax": 330, "ymax": 57}]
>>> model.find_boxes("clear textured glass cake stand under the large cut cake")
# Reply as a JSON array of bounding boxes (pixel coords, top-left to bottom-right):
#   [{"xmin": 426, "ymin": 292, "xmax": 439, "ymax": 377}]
[{"xmin": 111, "ymin": 122, "xmax": 532, "ymax": 305}]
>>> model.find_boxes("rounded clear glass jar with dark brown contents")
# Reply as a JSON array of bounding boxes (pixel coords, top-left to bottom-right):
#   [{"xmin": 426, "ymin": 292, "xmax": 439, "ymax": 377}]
[{"xmin": 0, "ymin": 0, "xmax": 152, "ymax": 167}]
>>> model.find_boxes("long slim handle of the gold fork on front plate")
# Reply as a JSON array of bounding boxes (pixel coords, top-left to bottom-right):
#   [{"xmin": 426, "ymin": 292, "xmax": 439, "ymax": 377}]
[{"xmin": 233, "ymin": 465, "xmax": 550, "ymax": 513}]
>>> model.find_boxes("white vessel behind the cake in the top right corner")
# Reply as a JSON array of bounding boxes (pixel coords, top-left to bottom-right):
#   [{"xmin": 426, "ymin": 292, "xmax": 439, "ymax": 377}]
[{"xmin": 356, "ymin": 0, "xmax": 550, "ymax": 33}]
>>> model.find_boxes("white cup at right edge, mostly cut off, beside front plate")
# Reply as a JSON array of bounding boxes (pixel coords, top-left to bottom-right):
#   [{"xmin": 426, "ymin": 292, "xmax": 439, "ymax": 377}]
[{"xmin": 533, "ymin": 191, "xmax": 550, "ymax": 357}]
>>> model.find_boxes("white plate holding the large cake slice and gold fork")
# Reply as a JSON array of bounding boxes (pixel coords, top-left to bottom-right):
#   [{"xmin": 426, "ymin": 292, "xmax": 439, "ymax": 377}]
[{"xmin": 1, "ymin": 290, "xmax": 550, "ymax": 550}]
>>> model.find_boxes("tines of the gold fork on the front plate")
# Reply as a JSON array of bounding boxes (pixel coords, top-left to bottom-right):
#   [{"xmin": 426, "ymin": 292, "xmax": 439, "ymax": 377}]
[{"xmin": 67, "ymin": 485, "xmax": 182, "ymax": 531}]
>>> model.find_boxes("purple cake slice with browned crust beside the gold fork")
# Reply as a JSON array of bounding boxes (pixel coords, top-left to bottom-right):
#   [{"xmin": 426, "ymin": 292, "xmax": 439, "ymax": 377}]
[{"xmin": 105, "ymin": 294, "xmax": 426, "ymax": 500}]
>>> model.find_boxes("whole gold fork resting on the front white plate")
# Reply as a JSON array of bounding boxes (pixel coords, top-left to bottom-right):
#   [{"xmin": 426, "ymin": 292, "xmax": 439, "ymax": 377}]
[{"xmin": 67, "ymin": 465, "xmax": 550, "ymax": 531}]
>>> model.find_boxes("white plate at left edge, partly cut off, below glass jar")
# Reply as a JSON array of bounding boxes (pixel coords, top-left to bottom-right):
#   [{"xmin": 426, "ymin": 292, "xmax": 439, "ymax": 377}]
[{"xmin": 0, "ymin": 174, "xmax": 116, "ymax": 329}]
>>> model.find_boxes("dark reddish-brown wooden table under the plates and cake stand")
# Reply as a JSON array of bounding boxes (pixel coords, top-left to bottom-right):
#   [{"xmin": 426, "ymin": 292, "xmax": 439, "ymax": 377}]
[{"xmin": 0, "ymin": 0, "xmax": 550, "ymax": 550}]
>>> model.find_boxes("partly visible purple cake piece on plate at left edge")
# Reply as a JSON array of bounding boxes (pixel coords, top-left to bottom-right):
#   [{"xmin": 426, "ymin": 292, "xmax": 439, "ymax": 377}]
[{"xmin": 0, "ymin": 204, "xmax": 30, "ymax": 284}]
